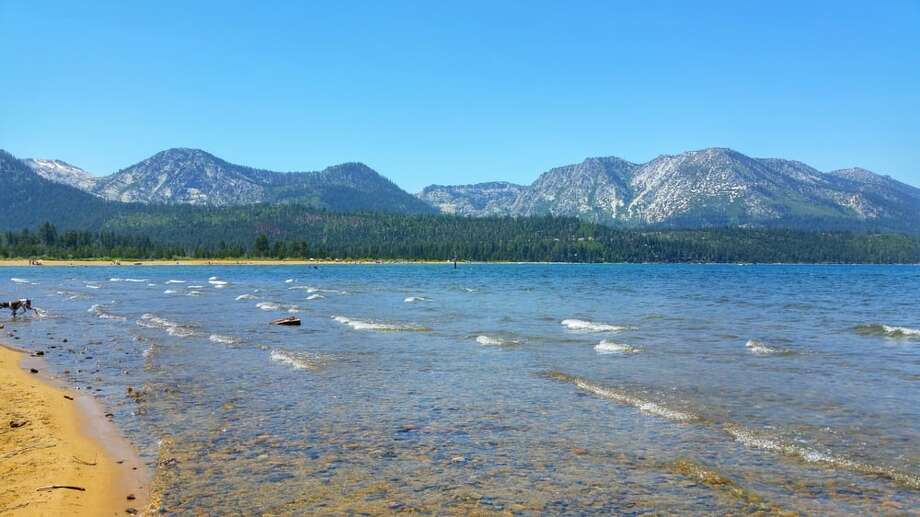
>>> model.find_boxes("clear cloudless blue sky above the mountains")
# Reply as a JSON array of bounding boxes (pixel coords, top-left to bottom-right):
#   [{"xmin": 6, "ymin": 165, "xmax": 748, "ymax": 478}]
[{"xmin": 0, "ymin": 0, "xmax": 920, "ymax": 191}]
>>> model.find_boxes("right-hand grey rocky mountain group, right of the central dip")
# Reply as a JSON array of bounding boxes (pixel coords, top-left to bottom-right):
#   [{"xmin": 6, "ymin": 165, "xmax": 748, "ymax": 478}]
[{"xmin": 418, "ymin": 148, "xmax": 920, "ymax": 231}]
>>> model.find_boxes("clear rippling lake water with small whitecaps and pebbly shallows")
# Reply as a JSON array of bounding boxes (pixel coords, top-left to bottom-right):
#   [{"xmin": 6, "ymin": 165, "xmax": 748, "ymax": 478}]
[{"xmin": 0, "ymin": 265, "xmax": 920, "ymax": 514}]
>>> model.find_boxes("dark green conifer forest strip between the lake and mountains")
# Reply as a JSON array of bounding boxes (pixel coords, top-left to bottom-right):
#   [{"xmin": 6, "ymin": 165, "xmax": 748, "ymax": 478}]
[{"xmin": 0, "ymin": 216, "xmax": 920, "ymax": 263}]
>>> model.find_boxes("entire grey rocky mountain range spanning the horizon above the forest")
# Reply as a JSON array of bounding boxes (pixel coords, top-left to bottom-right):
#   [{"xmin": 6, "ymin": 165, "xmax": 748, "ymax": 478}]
[{"xmin": 12, "ymin": 148, "xmax": 920, "ymax": 233}]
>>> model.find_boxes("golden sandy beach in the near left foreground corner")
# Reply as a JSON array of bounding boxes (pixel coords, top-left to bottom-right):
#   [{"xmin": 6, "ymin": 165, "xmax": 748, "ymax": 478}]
[{"xmin": 0, "ymin": 345, "xmax": 146, "ymax": 516}]
